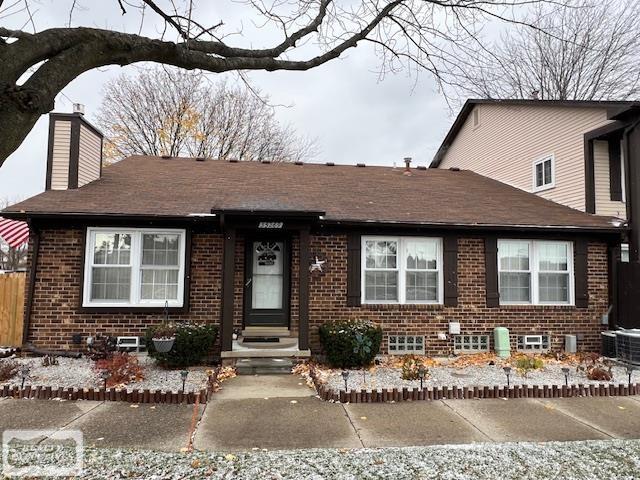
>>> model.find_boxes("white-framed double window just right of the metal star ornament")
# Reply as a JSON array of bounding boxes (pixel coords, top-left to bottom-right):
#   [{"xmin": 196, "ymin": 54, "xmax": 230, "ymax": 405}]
[{"xmin": 361, "ymin": 236, "xmax": 443, "ymax": 304}]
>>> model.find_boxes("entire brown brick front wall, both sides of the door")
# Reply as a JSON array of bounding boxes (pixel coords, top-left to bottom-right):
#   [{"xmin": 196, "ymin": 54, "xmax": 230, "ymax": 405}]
[{"xmin": 29, "ymin": 229, "xmax": 608, "ymax": 354}]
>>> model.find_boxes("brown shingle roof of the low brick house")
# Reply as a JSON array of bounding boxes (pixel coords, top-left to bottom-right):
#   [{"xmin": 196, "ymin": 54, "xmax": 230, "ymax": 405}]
[{"xmin": 5, "ymin": 156, "xmax": 624, "ymax": 230}]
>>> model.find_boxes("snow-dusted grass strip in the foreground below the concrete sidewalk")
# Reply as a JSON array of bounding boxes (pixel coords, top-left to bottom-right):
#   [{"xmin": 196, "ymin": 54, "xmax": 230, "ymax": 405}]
[{"xmin": 6, "ymin": 440, "xmax": 640, "ymax": 480}]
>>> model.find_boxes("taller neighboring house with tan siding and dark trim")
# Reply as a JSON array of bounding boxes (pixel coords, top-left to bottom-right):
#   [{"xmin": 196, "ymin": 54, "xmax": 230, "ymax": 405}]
[{"xmin": 431, "ymin": 100, "xmax": 640, "ymax": 328}]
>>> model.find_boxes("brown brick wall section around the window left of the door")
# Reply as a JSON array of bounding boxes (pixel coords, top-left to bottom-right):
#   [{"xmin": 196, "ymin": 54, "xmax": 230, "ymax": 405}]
[{"xmin": 28, "ymin": 229, "xmax": 222, "ymax": 349}]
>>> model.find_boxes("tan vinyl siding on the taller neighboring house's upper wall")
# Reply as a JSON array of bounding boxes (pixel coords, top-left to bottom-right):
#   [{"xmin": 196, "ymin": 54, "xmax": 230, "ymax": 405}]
[{"xmin": 440, "ymin": 104, "xmax": 609, "ymax": 211}]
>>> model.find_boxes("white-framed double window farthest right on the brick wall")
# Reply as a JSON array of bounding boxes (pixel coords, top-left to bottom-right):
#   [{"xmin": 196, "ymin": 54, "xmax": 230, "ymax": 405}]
[{"xmin": 498, "ymin": 240, "xmax": 574, "ymax": 305}]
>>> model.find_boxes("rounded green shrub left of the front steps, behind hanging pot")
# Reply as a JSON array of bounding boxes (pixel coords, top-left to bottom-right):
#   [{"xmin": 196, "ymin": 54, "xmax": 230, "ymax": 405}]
[{"xmin": 145, "ymin": 322, "xmax": 218, "ymax": 368}]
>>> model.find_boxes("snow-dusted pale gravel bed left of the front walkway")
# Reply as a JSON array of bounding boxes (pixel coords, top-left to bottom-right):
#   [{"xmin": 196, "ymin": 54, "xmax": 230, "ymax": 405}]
[{"xmin": 0, "ymin": 355, "xmax": 207, "ymax": 392}]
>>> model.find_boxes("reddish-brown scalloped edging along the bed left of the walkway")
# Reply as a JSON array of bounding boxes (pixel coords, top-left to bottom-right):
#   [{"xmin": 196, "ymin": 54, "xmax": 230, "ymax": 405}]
[{"xmin": 0, "ymin": 385, "xmax": 212, "ymax": 404}]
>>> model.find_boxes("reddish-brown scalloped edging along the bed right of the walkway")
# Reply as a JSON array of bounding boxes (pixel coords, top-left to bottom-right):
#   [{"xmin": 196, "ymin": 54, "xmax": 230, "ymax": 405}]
[{"xmin": 309, "ymin": 369, "xmax": 640, "ymax": 403}]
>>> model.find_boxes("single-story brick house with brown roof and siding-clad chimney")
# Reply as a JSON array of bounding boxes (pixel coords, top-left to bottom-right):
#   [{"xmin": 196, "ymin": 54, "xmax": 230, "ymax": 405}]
[{"xmin": 2, "ymin": 114, "xmax": 624, "ymax": 357}]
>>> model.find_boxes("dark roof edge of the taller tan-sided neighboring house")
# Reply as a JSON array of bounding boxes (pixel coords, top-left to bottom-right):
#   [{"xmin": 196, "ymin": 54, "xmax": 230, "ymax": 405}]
[{"xmin": 429, "ymin": 98, "xmax": 638, "ymax": 168}]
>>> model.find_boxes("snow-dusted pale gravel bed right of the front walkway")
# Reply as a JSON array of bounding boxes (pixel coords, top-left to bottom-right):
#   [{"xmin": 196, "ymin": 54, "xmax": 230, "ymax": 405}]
[{"xmin": 319, "ymin": 354, "xmax": 628, "ymax": 391}]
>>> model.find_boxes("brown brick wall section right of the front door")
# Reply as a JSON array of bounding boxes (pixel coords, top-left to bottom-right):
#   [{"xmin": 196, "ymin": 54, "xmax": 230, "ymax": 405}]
[{"xmin": 309, "ymin": 235, "xmax": 608, "ymax": 354}]
